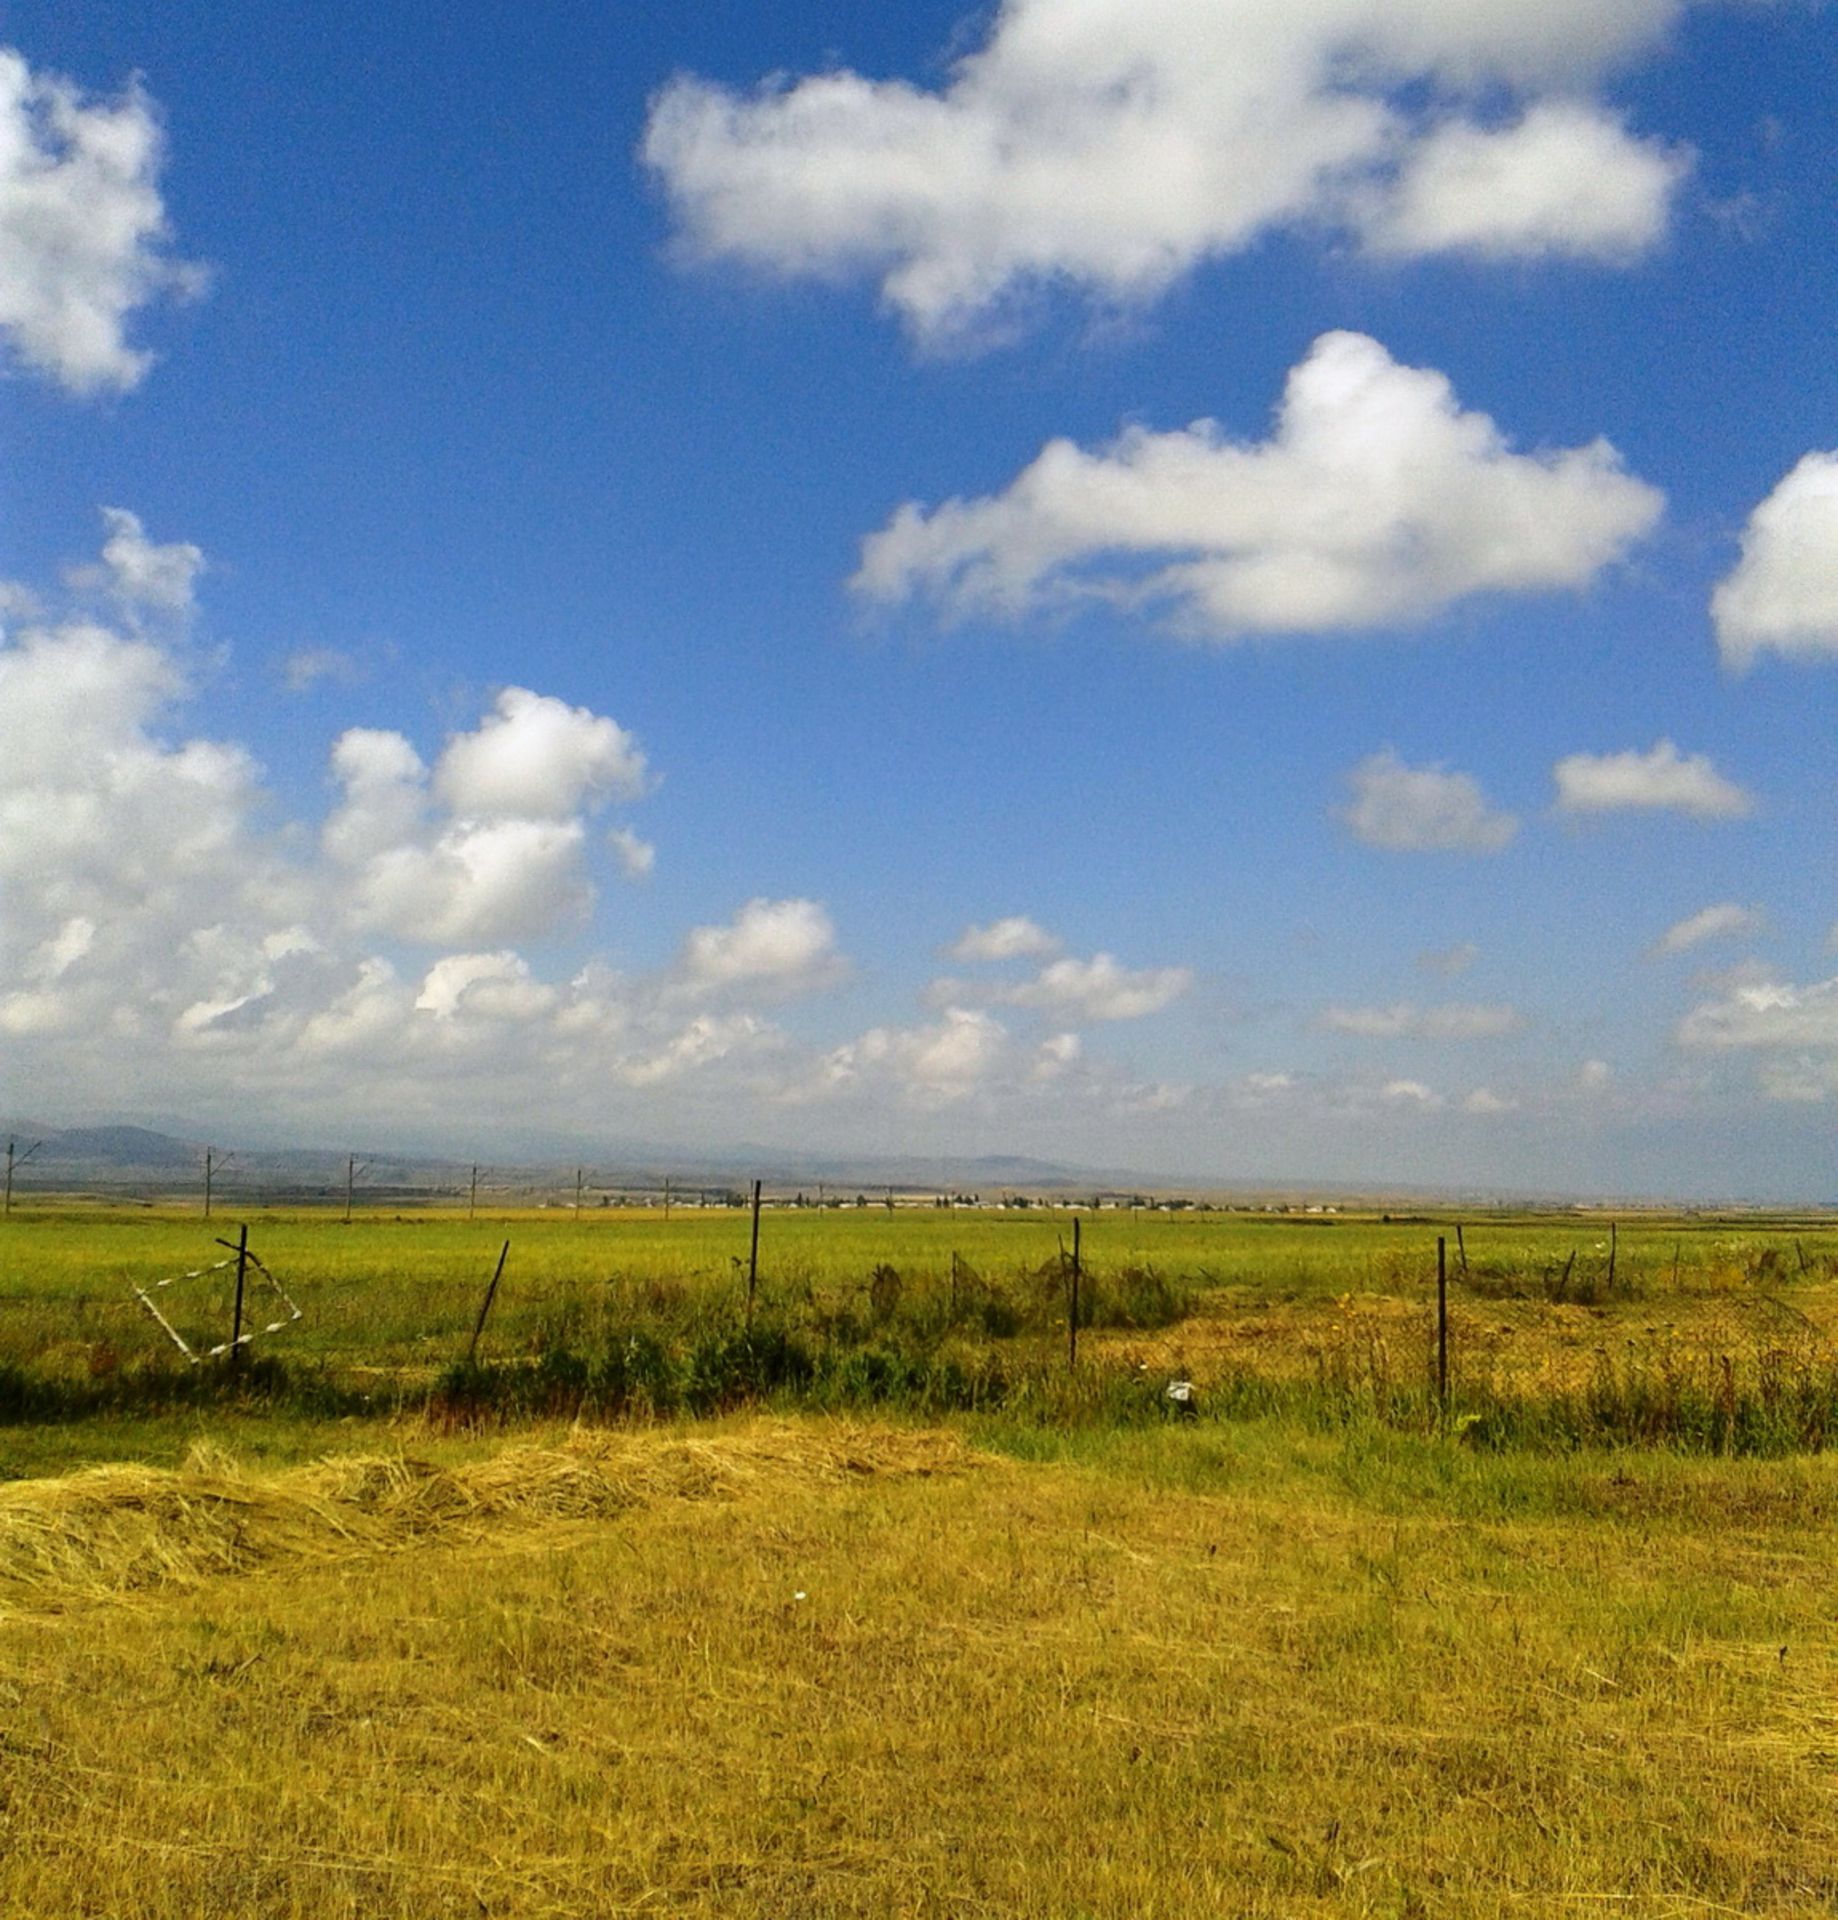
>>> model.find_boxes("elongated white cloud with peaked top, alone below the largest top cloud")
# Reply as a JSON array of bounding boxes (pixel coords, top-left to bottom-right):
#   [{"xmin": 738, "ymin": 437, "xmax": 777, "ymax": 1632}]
[{"xmin": 853, "ymin": 332, "xmax": 1661, "ymax": 639}]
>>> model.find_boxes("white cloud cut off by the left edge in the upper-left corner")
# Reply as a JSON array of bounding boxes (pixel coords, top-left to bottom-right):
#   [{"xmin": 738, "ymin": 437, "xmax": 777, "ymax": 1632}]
[{"xmin": 0, "ymin": 48, "xmax": 200, "ymax": 394}]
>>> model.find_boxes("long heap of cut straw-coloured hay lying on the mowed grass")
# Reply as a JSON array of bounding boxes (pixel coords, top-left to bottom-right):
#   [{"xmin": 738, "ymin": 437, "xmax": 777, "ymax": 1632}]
[{"xmin": 0, "ymin": 1423, "xmax": 976, "ymax": 1615}]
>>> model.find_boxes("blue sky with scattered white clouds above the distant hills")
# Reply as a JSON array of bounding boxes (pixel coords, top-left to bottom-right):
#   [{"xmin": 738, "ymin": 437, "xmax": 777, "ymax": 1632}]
[{"xmin": 0, "ymin": 0, "xmax": 1838, "ymax": 1196}]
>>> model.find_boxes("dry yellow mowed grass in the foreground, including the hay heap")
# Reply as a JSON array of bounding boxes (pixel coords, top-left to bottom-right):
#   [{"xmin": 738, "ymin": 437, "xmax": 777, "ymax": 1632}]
[{"xmin": 0, "ymin": 1423, "xmax": 1838, "ymax": 1920}]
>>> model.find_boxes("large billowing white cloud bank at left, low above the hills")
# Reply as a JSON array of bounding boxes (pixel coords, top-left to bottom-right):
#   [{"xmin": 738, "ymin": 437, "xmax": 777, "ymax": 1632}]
[{"xmin": 0, "ymin": 513, "xmax": 795, "ymax": 1119}]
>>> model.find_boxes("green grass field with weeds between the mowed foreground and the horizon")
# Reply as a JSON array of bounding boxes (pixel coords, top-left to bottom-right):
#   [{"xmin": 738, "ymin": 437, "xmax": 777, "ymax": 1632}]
[{"xmin": 0, "ymin": 1204, "xmax": 1838, "ymax": 1471}]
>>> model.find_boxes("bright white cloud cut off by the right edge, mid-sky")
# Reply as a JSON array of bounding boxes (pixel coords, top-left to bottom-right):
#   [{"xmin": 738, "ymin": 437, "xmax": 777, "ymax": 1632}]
[{"xmin": 1711, "ymin": 453, "xmax": 1838, "ymax": 672}]
